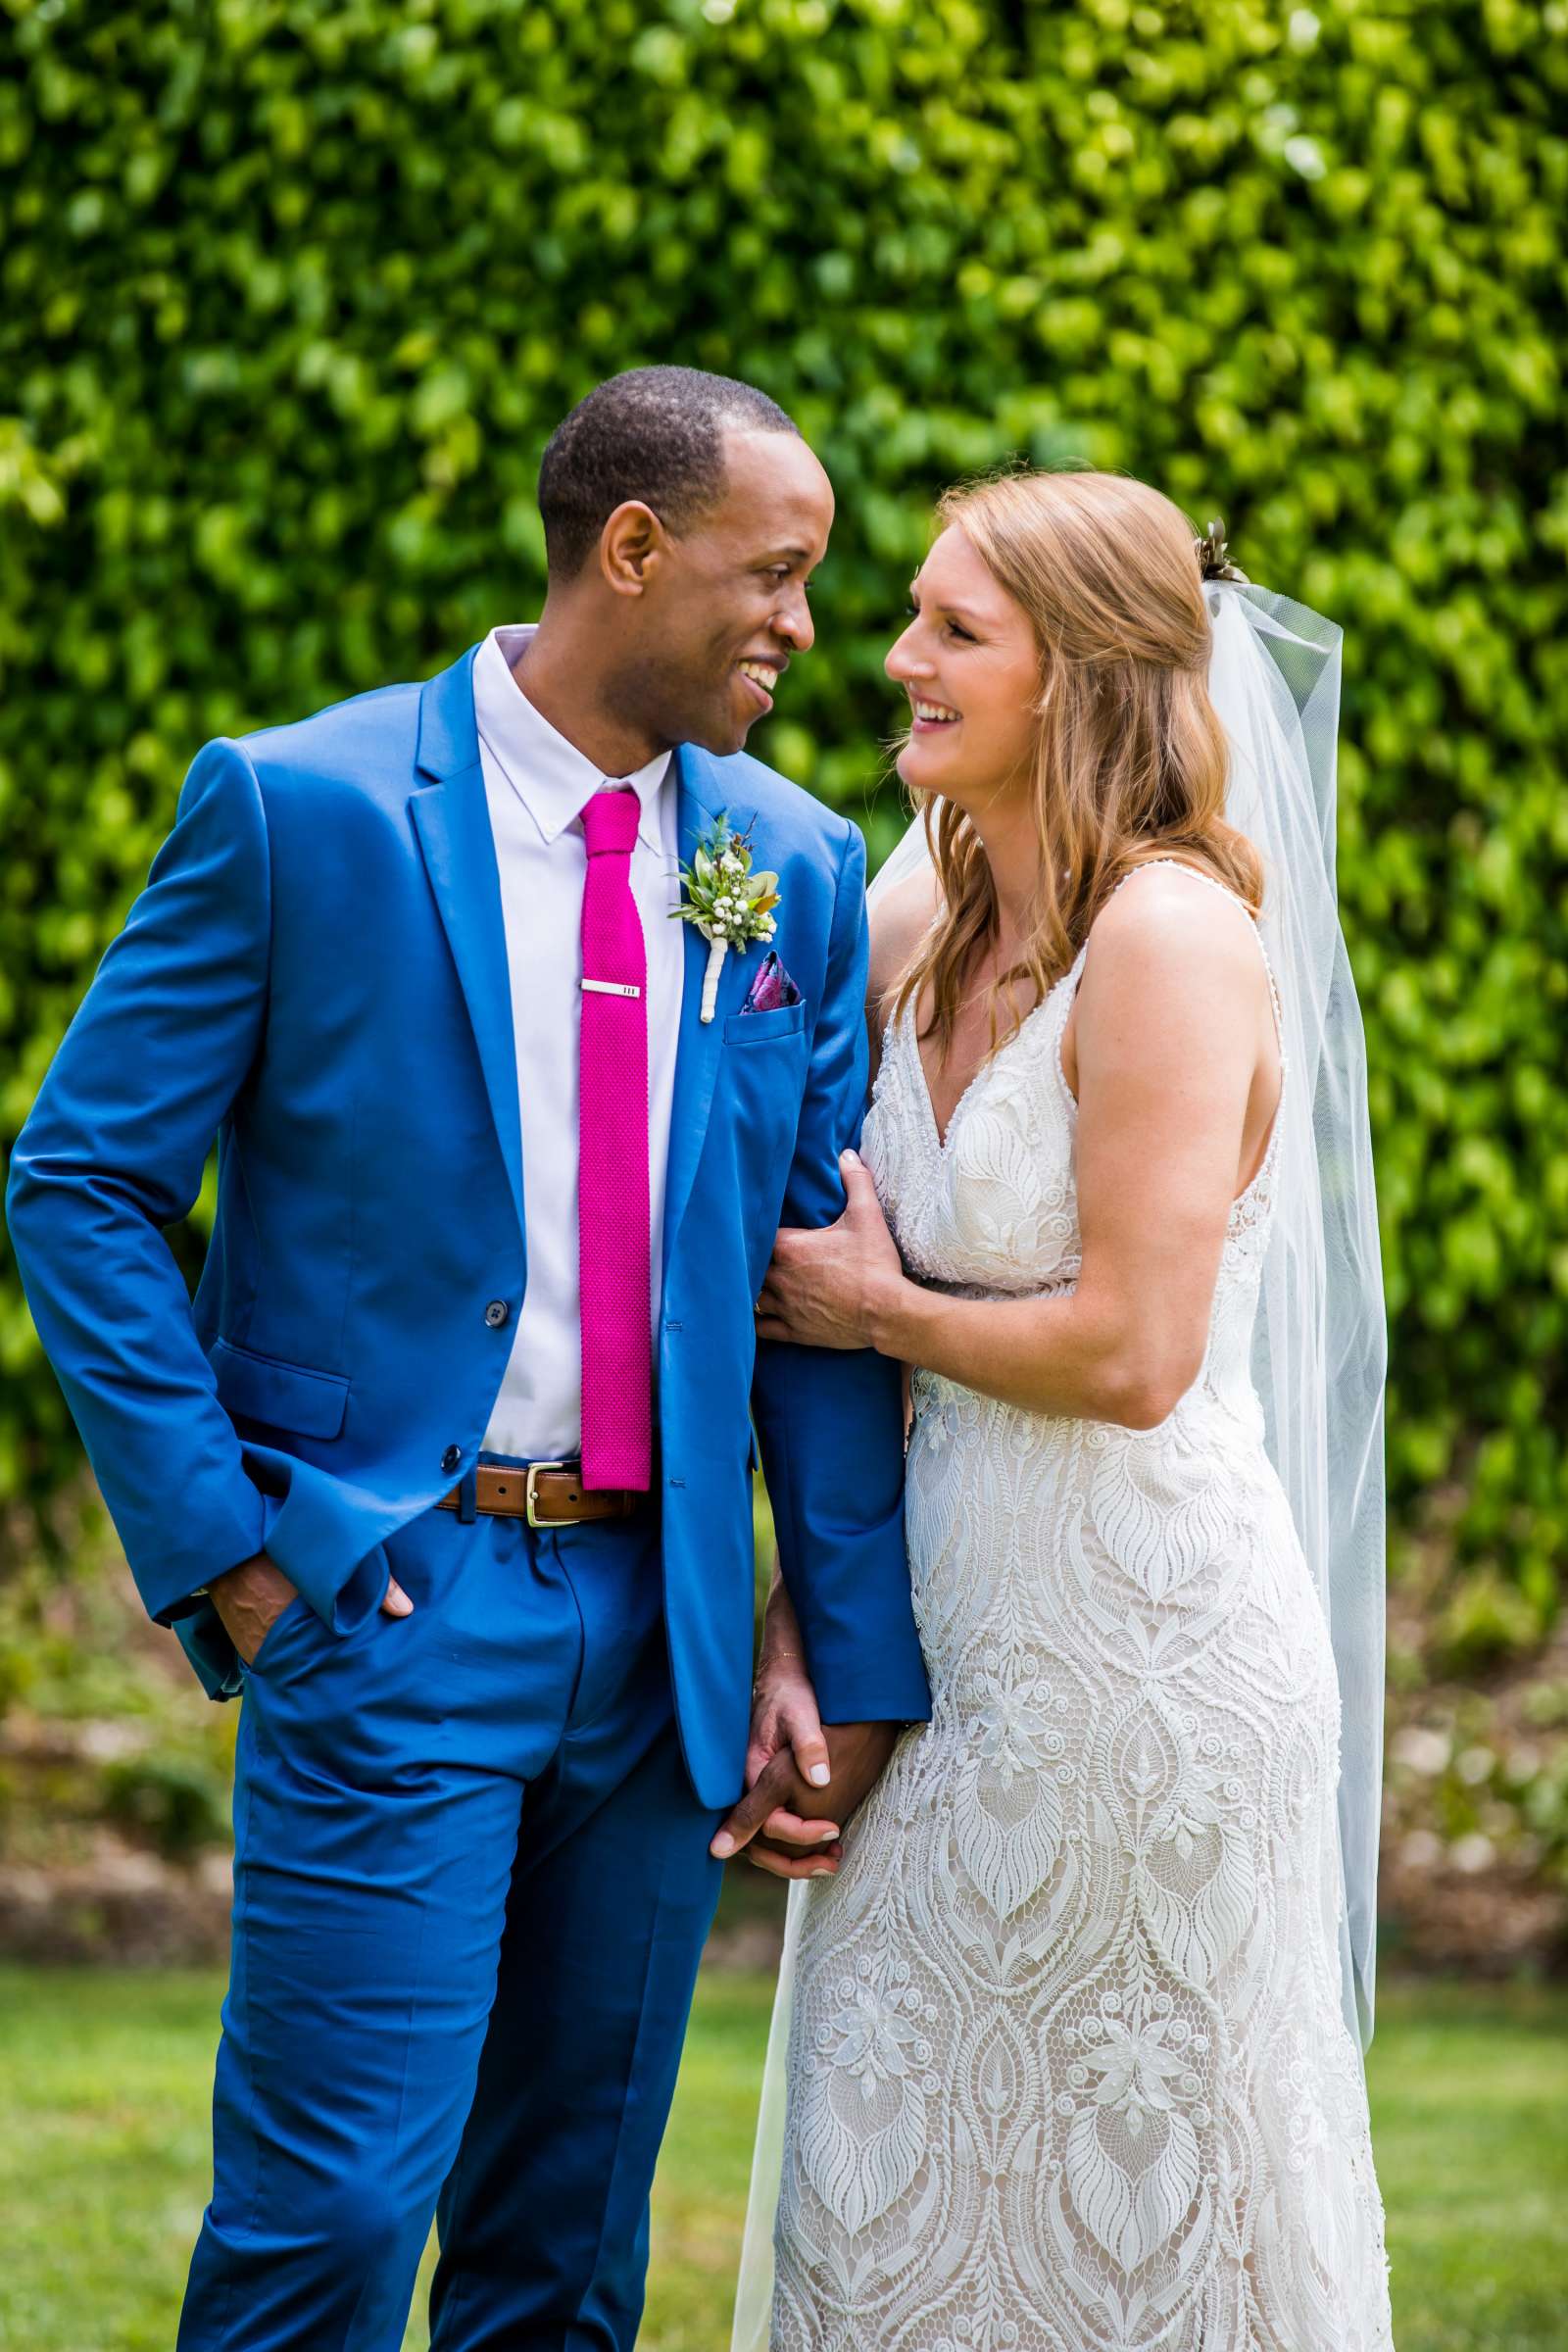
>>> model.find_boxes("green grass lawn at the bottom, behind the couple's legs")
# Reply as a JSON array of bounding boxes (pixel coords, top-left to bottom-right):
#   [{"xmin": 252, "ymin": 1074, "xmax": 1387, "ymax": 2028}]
[{"xmin": 0, "ymin": 1969, "xmax": 1568, "ymax": 2352}]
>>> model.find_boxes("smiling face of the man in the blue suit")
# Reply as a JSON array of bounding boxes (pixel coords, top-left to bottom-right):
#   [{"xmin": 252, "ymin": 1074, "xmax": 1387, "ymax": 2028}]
[{"xmin": 615, "ymin": 433, "xmax": 832, "ymax": 755}]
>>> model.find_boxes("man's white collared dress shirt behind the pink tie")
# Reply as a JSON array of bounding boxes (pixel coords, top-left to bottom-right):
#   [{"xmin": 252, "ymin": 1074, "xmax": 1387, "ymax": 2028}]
[{"xmin": 472, "ymin": 625, "xmax": 686, "ymax": 1460}]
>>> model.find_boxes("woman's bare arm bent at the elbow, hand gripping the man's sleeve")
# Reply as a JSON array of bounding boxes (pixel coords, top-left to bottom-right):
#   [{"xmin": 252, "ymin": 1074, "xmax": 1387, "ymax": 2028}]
[{"xmin": 761, "ymin": 877, "xmax": 1272, "ymax": 1428}]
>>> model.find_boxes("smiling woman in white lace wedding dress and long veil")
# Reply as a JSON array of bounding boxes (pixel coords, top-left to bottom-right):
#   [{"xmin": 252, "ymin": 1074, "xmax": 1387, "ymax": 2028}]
[{"xmin": 726, "ymin": 472, "xmax": 1390, "ymax": 2352}]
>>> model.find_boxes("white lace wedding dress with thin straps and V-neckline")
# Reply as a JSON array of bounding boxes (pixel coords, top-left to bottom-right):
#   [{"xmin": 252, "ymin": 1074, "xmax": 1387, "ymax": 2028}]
[{"xmin": 773, "ymin": 868, "xmax": 1390, "ymax": 2352}]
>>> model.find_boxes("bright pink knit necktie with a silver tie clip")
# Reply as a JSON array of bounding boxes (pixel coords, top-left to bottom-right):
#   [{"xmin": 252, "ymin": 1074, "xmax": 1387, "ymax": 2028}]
[{"xmin": 578, "ymin": 790, "xmax": 654, "ymax": 1492}]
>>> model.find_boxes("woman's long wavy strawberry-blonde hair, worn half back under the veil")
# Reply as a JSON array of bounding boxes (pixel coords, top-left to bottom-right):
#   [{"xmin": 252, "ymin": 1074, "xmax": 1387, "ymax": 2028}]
[{"xmin": 894, "ymin": 472, "xmax": 1262, "ymax": 1060}]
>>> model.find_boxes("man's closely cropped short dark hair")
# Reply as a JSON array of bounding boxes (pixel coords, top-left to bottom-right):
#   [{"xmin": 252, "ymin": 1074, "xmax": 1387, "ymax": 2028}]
[{"xmin": 538, "ymin": 367, "xmax": 800, "ymax": 578}]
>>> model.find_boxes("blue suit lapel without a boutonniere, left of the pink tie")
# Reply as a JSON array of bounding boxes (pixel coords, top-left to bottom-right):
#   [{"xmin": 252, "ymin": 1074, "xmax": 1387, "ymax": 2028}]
[{"xmin": 409, "ymin": 652, "xmax": 526, "ymax": 1233}]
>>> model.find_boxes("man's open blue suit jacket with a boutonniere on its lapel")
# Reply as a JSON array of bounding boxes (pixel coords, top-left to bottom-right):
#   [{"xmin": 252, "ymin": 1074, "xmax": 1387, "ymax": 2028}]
[{"xmin": 7, "ymin": 654, "xmax": 929, "ymax": 1806}]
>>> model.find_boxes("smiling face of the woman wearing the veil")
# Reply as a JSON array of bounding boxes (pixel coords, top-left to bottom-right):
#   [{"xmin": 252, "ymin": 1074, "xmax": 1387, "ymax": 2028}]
[{"xmin": 886, "ymin": 524, "xmax": 1039, "ymax": 816}]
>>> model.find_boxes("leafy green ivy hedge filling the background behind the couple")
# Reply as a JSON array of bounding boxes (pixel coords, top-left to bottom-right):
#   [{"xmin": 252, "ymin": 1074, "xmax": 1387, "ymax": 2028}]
[{"xmin": 0, "ymin": 0, "xmax": 1568, "ymax": 1623}]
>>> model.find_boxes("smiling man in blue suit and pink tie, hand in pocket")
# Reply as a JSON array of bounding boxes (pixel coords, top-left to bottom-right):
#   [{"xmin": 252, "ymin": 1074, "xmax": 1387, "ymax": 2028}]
[{"xmin": 10, "ymin": 367, "xmax": 926, "ymax": 2352}]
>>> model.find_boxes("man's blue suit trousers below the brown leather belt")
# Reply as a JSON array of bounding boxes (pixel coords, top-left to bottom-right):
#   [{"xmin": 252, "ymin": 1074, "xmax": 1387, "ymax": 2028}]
[{"xmin": 178, "ymin": 1456, "xmax": 719, "ymax": 2352}]
